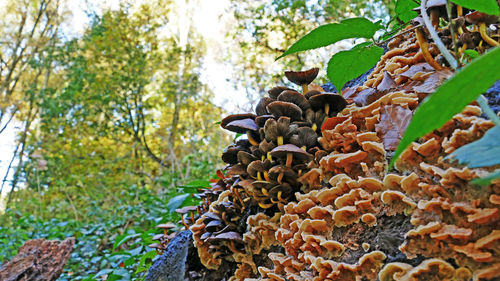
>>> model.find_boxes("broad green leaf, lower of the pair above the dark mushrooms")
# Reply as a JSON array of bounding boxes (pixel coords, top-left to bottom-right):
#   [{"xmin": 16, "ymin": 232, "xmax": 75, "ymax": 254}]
[{"xmin": 326, "ymin": 43, "xmax": 384, "ymax": 93}]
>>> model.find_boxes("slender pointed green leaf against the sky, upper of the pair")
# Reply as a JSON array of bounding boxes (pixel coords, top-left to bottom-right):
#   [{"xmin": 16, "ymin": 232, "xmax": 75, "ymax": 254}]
[{"xmin": 276, "ymin": 18, "xmax": 381, "ymax": 60}]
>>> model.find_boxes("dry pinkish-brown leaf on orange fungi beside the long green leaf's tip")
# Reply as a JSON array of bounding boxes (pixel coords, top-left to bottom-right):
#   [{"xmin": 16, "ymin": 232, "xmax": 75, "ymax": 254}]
[{"xmin": 375, "ymin": 105, "xmax": 412, "ymax": 150}]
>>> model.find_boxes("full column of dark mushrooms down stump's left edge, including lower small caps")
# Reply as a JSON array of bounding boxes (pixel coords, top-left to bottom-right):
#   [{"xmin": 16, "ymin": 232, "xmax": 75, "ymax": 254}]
[{"xmin": 191, "ymin": 68, "xmax": 347, "ymax": 268}]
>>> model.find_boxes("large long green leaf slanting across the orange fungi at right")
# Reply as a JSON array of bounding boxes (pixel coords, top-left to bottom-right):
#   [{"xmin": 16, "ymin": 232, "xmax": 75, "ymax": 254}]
[{"xmin": 389, "ymin": 47, "xmax": 500, "ymax": 169}]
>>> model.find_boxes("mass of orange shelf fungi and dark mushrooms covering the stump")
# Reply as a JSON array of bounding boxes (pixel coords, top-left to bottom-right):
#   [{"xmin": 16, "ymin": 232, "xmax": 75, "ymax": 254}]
[{"xmin": 180, "ymin": 6, "xmax": 500, "ymax": 281}]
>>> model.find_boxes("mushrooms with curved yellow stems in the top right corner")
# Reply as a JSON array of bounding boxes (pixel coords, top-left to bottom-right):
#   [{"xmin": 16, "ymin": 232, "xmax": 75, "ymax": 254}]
[{"xmin": 413, "ymin": 0, "xmax": 500, "ymax": 70}]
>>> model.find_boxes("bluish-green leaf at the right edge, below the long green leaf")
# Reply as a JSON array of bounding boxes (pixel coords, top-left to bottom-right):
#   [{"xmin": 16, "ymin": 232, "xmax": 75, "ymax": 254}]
[{"xmin": 446, "ymin": 126, "xmax": 500, "ymax": 168}]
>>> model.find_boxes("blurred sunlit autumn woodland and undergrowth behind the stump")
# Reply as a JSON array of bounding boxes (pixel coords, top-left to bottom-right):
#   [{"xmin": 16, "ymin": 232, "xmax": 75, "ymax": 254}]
[{"xmin": 0, "ymin": 0, "xmax": 394, "ymax": 280}]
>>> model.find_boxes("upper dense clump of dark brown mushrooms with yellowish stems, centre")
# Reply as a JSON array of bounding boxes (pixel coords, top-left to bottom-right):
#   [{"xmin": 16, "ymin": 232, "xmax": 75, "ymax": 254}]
[{"xmin": 221, "ymin": 68, "xmax": 347, "ymax": 210}]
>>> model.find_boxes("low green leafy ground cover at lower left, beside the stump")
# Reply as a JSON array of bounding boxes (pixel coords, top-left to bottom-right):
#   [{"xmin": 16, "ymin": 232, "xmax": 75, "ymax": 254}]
[{"xmin": 0, "ymin": 184, "xmax": 195, "ymax": 280}]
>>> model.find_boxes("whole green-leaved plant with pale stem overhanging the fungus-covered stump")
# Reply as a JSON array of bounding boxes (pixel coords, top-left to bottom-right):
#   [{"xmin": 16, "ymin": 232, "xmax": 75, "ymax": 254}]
[{"xmin": 277, "ymin": 0, "xmax": 500, "ymax": 184}]
